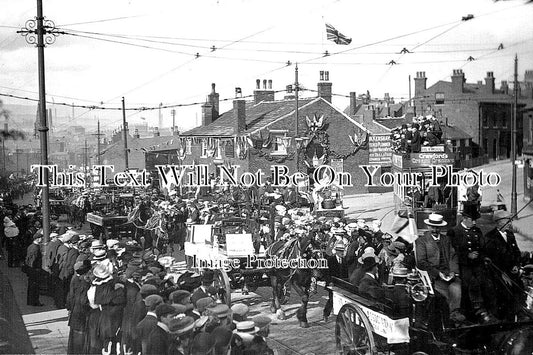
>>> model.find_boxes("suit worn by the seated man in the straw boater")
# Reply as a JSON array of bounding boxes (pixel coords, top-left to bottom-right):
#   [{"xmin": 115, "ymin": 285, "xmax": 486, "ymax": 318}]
[{"xmin": 415, "ymin": 232, "xmax": 461, "ymax": 312}]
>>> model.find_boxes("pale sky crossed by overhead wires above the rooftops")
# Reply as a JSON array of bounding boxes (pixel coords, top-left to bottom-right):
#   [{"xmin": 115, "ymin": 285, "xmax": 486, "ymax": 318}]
[{"xmin": 0, "ymin": 0, "xmax": 533, "ymax": 131}]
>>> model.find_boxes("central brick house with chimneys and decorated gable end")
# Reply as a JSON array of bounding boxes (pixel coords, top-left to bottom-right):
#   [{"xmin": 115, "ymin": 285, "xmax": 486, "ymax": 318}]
[{"xmin": 146, "ymin": 72, "xmax": 376, "ymax": 193}]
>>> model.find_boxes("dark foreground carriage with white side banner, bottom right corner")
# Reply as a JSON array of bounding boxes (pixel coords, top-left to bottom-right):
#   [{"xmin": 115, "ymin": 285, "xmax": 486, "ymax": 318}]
[{"xmin": 332, "ymin": 273, "xmax": 533, "ymax": 355}]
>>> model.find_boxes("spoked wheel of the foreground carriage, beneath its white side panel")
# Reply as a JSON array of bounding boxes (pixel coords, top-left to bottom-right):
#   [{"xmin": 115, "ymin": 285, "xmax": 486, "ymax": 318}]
[{"xmin": 335, "ymin": 304, "xmax": 377, "ymax": 355}]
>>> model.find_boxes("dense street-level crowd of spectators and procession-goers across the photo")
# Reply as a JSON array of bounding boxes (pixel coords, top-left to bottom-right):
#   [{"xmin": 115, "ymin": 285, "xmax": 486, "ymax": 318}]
[{"xmin": 0, "ymin": 172, "xmax": 531, "ymax": 355}]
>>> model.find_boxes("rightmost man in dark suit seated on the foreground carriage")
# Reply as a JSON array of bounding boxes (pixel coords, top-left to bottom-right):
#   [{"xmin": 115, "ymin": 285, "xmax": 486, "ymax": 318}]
[{"xmin": 482, "ymin": 210, "xmax": 522, "ymax": 320}]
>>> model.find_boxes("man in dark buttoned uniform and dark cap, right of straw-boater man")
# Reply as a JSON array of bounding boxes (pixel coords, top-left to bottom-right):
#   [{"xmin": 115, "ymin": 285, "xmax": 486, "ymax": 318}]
[{"xmin": 447, "ymin": 204, "xmax": 494, "ymax": 323}]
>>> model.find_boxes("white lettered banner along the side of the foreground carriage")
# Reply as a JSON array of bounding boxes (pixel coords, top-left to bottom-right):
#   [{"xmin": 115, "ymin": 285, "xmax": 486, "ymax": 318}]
[{"xmin": 333, "ymin": 291, "xmax": 410, "ymax": 344}]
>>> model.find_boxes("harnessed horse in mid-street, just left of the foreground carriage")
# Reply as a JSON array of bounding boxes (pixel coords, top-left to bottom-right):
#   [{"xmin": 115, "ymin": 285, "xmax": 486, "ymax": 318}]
[{"xmin": 265, "ymin": 236, "xmax": 321, "ymax": 328}]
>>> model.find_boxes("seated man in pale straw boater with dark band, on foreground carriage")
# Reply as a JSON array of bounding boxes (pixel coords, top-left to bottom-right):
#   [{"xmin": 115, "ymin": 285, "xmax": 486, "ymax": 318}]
[{"xmin": 416, "ymin": 213, "xmax": 465, "ymax": 324}]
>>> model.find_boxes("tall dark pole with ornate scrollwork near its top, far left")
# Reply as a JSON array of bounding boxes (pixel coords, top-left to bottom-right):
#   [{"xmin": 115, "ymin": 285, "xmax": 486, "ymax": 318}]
[{"xmin": 17, "ymin": 0, "xmax": 62, "ymax": 244}]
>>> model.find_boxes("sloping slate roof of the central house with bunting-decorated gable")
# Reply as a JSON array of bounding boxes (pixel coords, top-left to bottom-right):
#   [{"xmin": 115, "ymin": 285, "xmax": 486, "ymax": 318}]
[{"xmin": 181, "ymin": 97, "xmax": 317, "ymax": 137}]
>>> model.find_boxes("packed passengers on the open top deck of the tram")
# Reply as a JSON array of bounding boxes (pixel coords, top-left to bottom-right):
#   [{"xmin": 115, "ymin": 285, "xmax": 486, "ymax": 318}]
[{"xmin": 391, "ymin": 115, "xmax": 443, "ymax": 154}]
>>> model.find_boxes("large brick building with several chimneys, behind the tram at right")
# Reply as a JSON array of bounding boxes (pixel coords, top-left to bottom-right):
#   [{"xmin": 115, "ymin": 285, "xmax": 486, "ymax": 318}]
[{"xmin": 413, "ymin": 69, "xmax": 533, "ymax": 159}]
